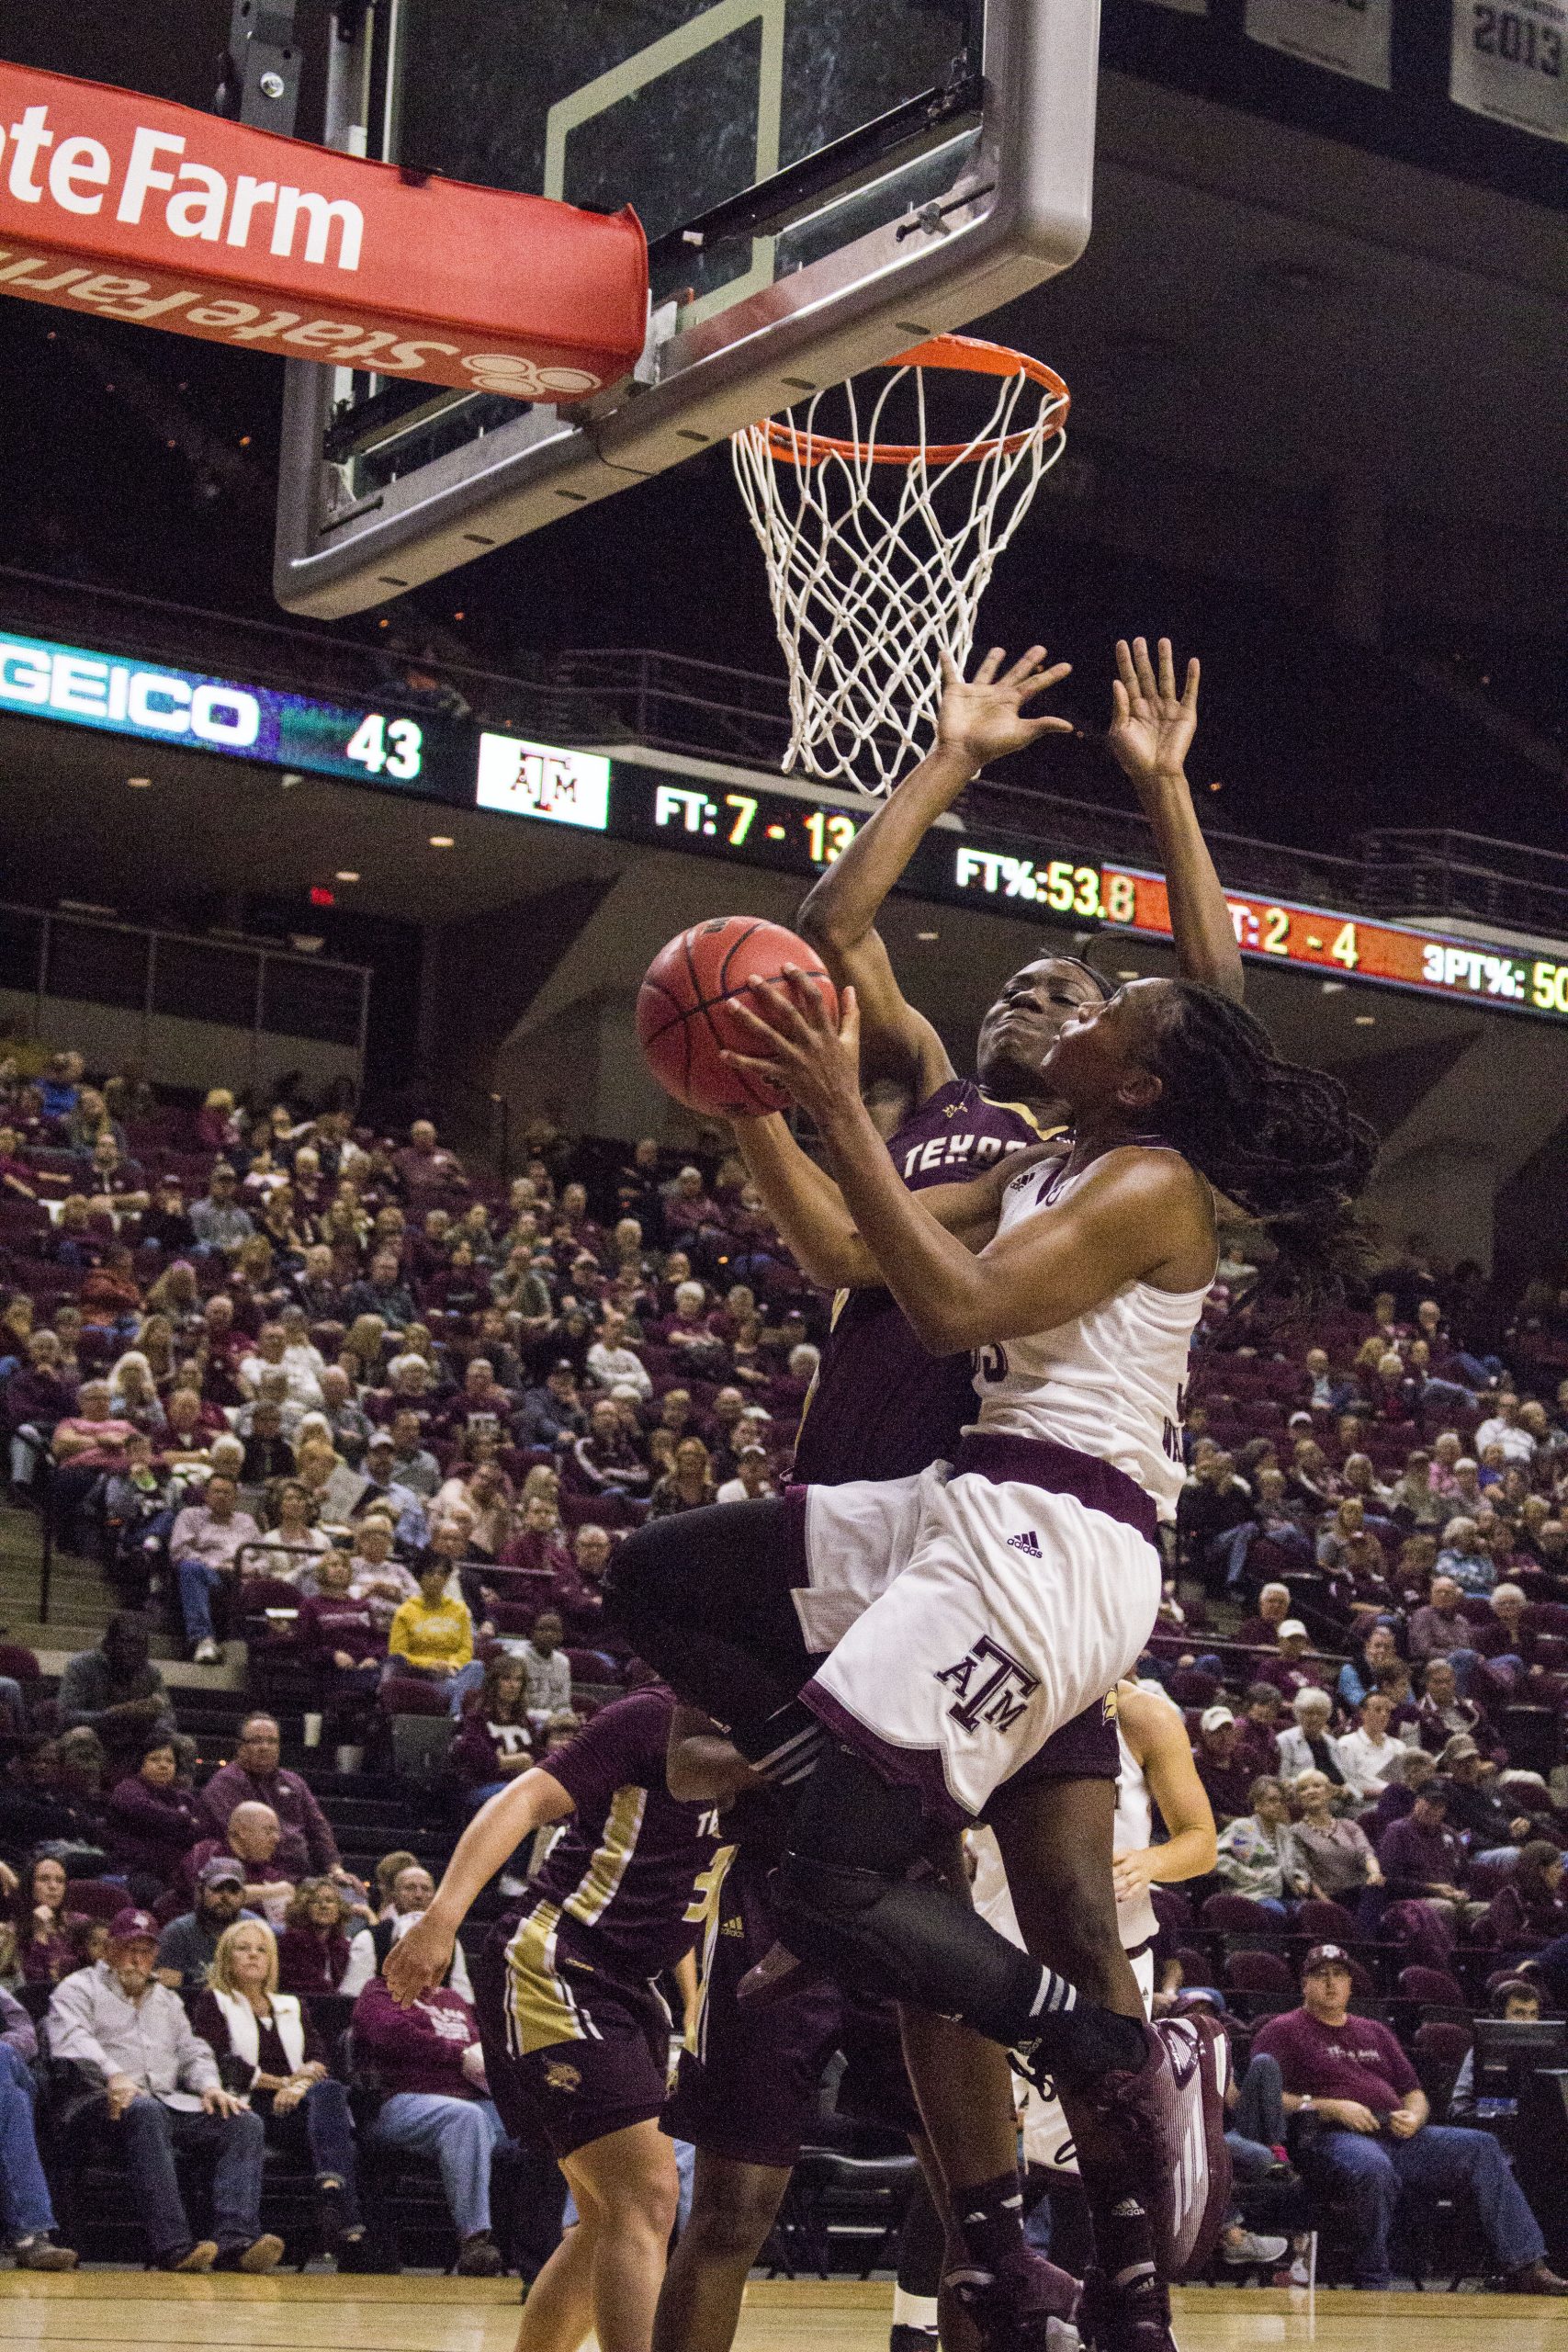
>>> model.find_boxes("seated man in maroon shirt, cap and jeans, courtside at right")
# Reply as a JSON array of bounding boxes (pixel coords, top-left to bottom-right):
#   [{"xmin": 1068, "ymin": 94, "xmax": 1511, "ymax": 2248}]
[{"xmin": 1253, "ymin": 1943, "xmax": 1568, "ymax": 2296}]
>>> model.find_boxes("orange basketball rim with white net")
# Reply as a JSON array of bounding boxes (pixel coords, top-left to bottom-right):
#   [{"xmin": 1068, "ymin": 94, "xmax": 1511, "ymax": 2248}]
[{"xmin": 731, "ymin": 334, "xmax": 1069, "ymax": 795}]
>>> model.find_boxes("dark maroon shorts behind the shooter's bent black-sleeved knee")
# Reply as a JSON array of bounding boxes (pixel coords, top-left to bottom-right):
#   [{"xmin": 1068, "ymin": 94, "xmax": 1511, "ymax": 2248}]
[{"xmin": 663, "ymin": 1849, "xmax": 921, "ymax": 2171}]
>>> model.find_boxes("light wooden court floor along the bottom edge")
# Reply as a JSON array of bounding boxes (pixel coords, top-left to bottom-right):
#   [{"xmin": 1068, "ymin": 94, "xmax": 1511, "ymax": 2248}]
[{"xmin": 0, "ymin": 2269, "xmax": 1568, "ymax": 2352}]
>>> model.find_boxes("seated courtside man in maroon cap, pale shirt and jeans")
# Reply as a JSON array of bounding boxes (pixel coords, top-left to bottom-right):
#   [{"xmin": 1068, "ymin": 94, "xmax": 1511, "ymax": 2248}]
[{"xmin": 50, "ymin": 1910, "xmax": 282, "ymax": 2275}]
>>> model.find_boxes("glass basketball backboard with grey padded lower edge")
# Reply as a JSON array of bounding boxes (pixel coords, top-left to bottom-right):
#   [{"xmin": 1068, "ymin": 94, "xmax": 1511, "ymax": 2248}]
[{"xmin": 275, "ymin": 0, "xmax": 1098, "ymax": 618}]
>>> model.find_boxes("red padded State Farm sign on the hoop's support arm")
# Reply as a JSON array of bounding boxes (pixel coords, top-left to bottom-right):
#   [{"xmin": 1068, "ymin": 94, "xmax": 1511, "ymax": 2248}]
[{"xmin": 0, "ymin": 63, "xmax": 649, "ymax": 400}]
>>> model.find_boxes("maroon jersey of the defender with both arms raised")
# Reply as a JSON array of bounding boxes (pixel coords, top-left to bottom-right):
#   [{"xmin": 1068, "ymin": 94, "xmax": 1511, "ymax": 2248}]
[{"xmin": 795, "ymin": 1077, "xmax": 1055, "ymax": 1487}]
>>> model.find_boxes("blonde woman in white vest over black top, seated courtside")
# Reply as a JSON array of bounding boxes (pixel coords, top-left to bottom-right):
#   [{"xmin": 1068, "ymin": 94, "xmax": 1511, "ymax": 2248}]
[{"xmin": 190, "ymin": 1919, "xmax": 365, "ymax": 2267}]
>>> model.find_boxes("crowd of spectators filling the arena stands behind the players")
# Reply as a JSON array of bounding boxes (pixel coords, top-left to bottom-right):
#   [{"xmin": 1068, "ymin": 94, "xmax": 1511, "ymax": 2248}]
[{"xmin": 0, "ymin": 1054, "xmax": 1568, "ymax": 2284}]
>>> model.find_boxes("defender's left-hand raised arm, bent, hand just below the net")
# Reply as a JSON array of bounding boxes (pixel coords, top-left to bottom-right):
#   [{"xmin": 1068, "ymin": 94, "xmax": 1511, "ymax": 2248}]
[{"xmin": 797, "ymin": 644, "xmax": 1072, "ymax": 1103}]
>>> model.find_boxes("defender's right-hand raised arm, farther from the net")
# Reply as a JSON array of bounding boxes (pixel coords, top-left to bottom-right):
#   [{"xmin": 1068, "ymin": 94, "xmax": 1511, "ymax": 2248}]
[{"xmin": 1105, "ymin": 638, "xmax": 1244, "ymax": 997}]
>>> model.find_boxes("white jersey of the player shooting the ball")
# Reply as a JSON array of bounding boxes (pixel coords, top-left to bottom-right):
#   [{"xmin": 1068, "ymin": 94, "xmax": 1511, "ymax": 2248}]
[{"xmin": 976, "ymin": 1167, "xmax": 1208, "ymax": 1520}]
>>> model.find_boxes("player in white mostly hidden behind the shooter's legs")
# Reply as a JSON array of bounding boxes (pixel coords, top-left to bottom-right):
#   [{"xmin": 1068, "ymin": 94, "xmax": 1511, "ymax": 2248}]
[{"xmin": 968, "ymin": 1681, "xmax": 1286, "ymax": 2265}]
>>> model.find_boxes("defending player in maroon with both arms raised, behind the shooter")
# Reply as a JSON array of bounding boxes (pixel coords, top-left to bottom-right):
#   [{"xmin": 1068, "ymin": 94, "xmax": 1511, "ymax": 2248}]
[{"xmin": 660, "ymin": 639, "xmax": 1241, "ymax": 2352}]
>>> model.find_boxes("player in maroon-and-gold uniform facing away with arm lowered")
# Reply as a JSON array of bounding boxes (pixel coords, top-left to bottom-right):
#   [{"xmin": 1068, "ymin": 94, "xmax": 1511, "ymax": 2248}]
[{"xmin": 386, "ymin": 1684, "xmax": 719, "ymax": 2352}]
